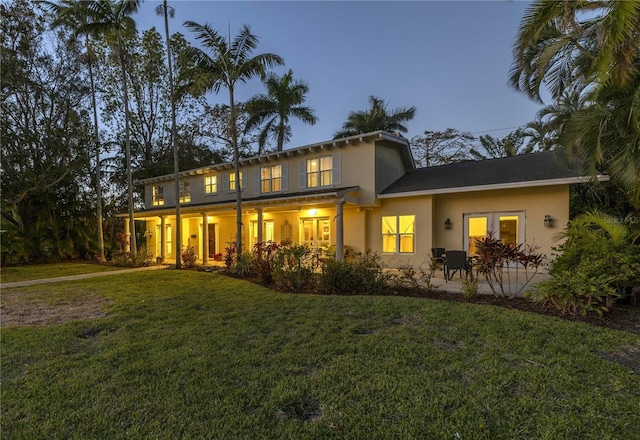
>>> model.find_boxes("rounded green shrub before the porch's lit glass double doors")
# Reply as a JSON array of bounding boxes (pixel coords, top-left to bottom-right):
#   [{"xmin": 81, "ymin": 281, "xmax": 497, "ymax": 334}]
[{"xmin": 272, "ymin": 245, "xmax": 315, "ymax": 291}]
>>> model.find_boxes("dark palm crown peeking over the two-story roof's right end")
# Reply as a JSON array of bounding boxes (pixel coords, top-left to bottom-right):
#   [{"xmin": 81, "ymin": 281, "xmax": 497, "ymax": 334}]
[{"xmin": 333, "ymin": 96, "xmax": 416, "ymax": 139}]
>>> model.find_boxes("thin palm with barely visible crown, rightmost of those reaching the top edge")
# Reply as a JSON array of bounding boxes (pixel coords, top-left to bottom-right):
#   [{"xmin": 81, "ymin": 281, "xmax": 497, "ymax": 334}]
[{"xmin": 156, "ymin": 0, "xmax": 181, "ymax": 269}]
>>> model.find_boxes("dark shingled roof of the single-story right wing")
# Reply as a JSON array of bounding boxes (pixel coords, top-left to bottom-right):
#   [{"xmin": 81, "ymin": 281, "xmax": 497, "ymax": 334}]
[{"xmin": 381, "ymin": 151, "xmax": 580, "ymax": 194}]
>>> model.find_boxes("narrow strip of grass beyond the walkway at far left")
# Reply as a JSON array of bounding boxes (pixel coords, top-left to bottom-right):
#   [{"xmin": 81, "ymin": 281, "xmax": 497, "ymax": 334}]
[{"xmin": 0, "ymin": 263, "xmax": 125, "ymax": 283}]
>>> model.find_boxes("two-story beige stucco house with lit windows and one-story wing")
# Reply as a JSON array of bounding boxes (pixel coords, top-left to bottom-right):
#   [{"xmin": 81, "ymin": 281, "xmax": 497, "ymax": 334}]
[{"xmin": 130, "ymin": 132, "xmax": 604, "ymax": 267}]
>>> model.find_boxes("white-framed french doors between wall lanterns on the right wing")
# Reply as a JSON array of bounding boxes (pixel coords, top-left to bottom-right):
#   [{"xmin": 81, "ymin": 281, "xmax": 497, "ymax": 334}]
[{"xmin": 464, "ymin": 211, "xmax": 525, "ymax": 255}]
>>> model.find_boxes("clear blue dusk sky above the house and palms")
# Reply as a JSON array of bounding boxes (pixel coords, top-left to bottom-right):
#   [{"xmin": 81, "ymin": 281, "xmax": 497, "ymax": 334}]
[{"xmin": 134, "ymin": 0, "xmax": 540, "ymax": 148}]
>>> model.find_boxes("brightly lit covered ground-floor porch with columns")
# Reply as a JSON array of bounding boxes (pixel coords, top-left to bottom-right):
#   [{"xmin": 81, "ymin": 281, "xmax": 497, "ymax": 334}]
[{"xmin": 125, "ymin": 187, "xmax": 367, "ymax": 265}]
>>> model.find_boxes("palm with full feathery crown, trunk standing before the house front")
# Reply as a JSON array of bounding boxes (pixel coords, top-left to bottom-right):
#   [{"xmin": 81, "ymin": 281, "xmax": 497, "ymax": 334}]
[{"xmin": 184, "ymin": 21, "xmax": 284, "ymax": 252}]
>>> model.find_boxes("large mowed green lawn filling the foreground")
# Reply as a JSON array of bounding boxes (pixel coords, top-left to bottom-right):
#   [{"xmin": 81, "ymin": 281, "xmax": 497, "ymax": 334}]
[{"xmin": 1, "ymin": 270, "xmax": 640, "ymax": 439}]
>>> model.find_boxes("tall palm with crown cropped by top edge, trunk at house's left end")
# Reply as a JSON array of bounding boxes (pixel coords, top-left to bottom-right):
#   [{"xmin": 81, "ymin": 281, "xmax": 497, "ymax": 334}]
[{"xmin": 79, "ymin": 0, "xmax": 142, "ymax": 261}]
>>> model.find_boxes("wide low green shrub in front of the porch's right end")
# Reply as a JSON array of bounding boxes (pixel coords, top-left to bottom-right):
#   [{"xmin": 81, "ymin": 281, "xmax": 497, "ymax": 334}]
[{"xmin": 319, "ymin": 251, "xmax": 389, "ymax": 295}]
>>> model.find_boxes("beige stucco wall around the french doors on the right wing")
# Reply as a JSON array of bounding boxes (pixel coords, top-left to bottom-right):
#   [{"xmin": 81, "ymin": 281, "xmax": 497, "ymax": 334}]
[{"xmin": 433, "ymin": 185, "xmax": 569, "ymax": 255}]
